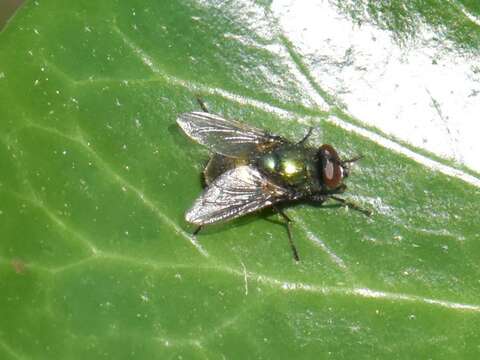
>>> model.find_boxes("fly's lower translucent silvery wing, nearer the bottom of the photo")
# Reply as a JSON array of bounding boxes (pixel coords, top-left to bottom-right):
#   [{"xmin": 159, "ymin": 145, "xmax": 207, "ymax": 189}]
[{"xmin": 185, "ymin": 166, "xmax": 291, "ymax": 225}]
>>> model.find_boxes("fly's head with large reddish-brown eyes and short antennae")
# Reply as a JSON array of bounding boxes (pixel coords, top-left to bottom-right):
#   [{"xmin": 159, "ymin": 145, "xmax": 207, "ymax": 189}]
[{"xmin": 317, "ymin": 144, "xmax": 361, "ymax": 193}]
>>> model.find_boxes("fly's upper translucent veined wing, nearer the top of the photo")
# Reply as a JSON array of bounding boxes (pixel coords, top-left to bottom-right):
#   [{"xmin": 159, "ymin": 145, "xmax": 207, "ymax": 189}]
[{"xmin": 177, "ymin": 112, "xmax": 287, "ymax": 158}]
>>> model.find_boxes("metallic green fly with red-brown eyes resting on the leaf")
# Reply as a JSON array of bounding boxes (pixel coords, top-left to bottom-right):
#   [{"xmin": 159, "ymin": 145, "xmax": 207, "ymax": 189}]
[{"xmin": 177, "ymin": 99, "xmax": 370, "ymax": 261}]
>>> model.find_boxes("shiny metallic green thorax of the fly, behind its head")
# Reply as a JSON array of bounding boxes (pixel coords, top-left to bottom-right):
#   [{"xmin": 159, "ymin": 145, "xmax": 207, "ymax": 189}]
[{"xmin": 256, "ymin": 147, "xmax": 313, "ymax": 186}]
